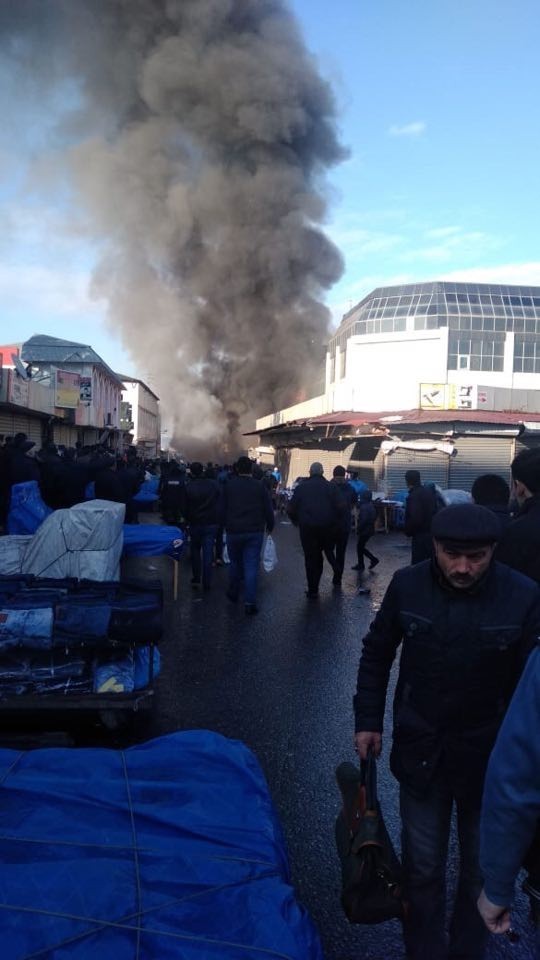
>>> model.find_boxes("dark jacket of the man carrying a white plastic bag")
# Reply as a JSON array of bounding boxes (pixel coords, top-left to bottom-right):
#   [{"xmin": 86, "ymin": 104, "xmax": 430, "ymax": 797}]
[{"xmin": 219, "ymin": 476, "xmax": 274, "ymax": 533}]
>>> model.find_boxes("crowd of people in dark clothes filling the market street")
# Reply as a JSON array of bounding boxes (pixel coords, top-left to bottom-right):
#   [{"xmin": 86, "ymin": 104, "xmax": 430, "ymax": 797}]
[{"xmin": 0, "ymin": 434, "xmax": 540, "ymax": 960}]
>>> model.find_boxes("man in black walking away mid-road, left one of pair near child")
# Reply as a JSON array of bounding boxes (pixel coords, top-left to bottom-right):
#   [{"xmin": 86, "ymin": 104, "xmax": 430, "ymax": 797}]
[{"xmin": 288, "ymin": 462, "xmax": 343, "ymax": 599}]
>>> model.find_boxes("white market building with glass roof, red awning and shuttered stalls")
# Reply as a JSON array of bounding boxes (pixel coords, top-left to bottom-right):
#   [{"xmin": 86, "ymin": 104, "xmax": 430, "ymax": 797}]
[{"xmin": 256, "ymin": 281, "xmax": 540, "ymax": 494}]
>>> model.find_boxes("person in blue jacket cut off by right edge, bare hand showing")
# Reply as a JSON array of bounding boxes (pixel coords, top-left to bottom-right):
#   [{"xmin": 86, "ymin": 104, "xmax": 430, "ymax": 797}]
[{"xmin": 478, "ymin": 647, "xmax": 540, "ymax": 960}]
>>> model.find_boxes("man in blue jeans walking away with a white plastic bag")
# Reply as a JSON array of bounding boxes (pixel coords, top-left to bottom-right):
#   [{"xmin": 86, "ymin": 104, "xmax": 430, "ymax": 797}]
[{"xmin": 221, "ymin": 457, "xmax": 274, "ymax": 614}]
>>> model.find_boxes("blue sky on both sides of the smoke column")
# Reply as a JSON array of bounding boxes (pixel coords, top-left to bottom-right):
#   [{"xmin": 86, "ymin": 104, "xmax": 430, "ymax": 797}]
[{"xmin": 0, "ymin": 0, "xmax": 540, "ymax": 377}]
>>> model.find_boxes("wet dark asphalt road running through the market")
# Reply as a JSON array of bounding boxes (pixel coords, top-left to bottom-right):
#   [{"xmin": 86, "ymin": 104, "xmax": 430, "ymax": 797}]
[{"xmin": 134, "ymin": 518, "xmax": 533, "ymax": 960}]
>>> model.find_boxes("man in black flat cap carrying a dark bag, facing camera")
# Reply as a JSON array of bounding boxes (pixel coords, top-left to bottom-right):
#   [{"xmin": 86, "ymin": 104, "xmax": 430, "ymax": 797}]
[{"xmin": 354, "ymin": 504, "xmax": 540, "ymax": 960}]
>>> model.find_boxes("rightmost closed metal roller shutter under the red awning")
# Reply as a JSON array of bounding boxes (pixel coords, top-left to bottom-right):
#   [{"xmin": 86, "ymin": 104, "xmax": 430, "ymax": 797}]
[{"xmin": 448, "ymin": 437, "xmax": 515, "ymax": 490}]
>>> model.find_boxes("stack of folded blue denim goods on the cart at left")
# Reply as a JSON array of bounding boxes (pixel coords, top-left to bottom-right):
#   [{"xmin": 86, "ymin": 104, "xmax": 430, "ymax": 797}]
[{"xmin": 0, "ymin": 576, "xmax": 163, "ymax": 700}]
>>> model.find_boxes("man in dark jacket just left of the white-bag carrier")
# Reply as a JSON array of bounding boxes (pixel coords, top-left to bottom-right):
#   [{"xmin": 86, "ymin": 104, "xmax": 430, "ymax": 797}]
[{"xmin": 185, "ymin": 461, "xmax": 219, "ymax": 590}]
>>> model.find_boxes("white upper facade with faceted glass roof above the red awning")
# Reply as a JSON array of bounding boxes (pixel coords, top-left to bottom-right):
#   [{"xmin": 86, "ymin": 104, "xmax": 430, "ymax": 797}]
[{"xmin": 257, "ymin": 282, "xmax": 540, "ymax": 429}]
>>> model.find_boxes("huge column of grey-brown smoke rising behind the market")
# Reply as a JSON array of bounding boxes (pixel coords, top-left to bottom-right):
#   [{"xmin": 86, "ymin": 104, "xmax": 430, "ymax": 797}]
[{"xmin": 0, "ymin": 0, "xmax": 344, "ymax": 453}]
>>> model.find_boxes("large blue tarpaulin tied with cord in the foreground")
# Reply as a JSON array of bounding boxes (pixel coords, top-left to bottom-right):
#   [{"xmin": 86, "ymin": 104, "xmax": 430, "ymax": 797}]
[{"xmin": 0, "ymin": 730, "xmax": 322, "ymax": 960}]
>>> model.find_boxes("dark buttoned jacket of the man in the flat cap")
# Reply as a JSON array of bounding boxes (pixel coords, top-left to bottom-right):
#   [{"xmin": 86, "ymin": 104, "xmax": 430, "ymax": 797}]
[{"xmin": 354, "ymin": 560, "xmax": 540, "ymax": 801}]
